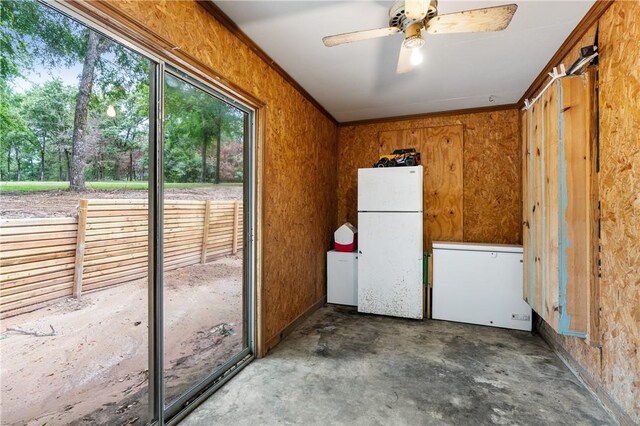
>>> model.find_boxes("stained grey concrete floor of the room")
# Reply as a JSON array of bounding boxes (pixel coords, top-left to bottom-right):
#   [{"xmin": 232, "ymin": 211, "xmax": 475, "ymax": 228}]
[{"xmin": 183, "ymin": 306, "xmax": 615, "ymax": 425}]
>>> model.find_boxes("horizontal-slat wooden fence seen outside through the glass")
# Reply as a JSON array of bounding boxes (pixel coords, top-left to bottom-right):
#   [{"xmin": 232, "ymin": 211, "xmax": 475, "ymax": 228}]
[{"xmin": 0, "ymin": 200, "xmax": 243, "ymax": 318}]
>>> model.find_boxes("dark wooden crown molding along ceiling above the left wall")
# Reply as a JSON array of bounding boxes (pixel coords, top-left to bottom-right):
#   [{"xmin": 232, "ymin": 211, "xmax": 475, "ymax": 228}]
[{"xmin": 197, "ymin": 0, "xmax": 338, "ymax": 126}]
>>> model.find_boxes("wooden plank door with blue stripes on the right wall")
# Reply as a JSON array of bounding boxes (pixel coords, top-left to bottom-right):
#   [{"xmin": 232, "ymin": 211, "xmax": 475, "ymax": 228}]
[{"xmin": 523, "ymin": 73, "xmax": 598, "ymax": 342}]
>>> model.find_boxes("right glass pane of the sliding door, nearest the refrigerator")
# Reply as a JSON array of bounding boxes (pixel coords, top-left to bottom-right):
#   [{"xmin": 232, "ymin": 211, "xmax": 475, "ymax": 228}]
[{"xmin": 162, "ymin": 72, "xmax": 254, "ymax": 418}]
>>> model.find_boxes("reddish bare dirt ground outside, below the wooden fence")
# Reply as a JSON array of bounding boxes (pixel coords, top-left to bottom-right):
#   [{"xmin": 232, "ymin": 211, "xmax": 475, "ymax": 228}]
[{"xmin": 0, "ymin": 255, "xmax": 243, "ymax": 425}]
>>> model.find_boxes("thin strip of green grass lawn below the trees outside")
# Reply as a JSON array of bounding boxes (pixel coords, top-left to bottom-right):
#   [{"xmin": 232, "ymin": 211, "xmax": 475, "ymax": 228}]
[{"xmin": 0, "ymin": 181, "xmax": 242, "ymax": 192}]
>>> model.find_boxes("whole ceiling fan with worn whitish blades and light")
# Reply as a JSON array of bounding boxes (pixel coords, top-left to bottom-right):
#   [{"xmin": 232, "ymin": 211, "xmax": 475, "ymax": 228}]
[{"xmin": 322, "ymin": 0, "xmax": 518, "ymax": 74}]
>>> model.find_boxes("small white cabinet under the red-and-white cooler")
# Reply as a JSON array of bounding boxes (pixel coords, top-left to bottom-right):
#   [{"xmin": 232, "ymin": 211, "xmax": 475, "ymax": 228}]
[{"xmin": 327, "ymin": 250, "xmax": 358, "ymax": 306}]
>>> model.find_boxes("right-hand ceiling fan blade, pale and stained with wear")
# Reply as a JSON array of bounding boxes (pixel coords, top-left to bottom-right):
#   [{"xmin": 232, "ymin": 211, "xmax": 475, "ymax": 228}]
[{"xmin": 425, "ymin": 4, "xmax": 518, "ymax": 34}]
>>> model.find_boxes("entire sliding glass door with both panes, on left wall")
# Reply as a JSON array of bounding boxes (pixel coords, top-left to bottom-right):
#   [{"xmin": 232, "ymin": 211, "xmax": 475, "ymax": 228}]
[{"xmin": 0, "ymin": 1, "xmax": 254, "ymax": 424}]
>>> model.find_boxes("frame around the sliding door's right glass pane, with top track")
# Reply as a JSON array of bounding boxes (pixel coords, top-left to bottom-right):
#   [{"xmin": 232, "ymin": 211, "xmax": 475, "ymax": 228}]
[{"xmin": 40, "ymin": 0, "xmax": 264, "ymax": 425}]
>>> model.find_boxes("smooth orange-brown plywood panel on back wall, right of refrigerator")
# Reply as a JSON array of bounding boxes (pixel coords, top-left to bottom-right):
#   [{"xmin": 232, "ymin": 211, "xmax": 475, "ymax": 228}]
[{"xmin": 421, "ymin": 125, "xmax": 464, "ymax": 251}]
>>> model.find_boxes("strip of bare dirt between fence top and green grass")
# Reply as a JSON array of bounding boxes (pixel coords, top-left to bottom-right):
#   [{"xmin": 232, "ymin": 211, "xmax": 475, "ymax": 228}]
[{"xmin": 0, "ymin": 185, "xmax": 242, "ymax": 219}]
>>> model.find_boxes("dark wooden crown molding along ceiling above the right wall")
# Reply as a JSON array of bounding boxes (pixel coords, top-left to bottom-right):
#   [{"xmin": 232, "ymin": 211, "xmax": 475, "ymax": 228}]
[{"xmin": 518, "ymin": 0, "xmax": 615, "ymax": 106}]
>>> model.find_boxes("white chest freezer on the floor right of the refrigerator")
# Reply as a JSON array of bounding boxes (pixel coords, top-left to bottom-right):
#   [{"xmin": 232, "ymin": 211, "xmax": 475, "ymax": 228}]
[{"xmin": 432, "ymin": 241, "xmax": 531, "ymax": 331}]
